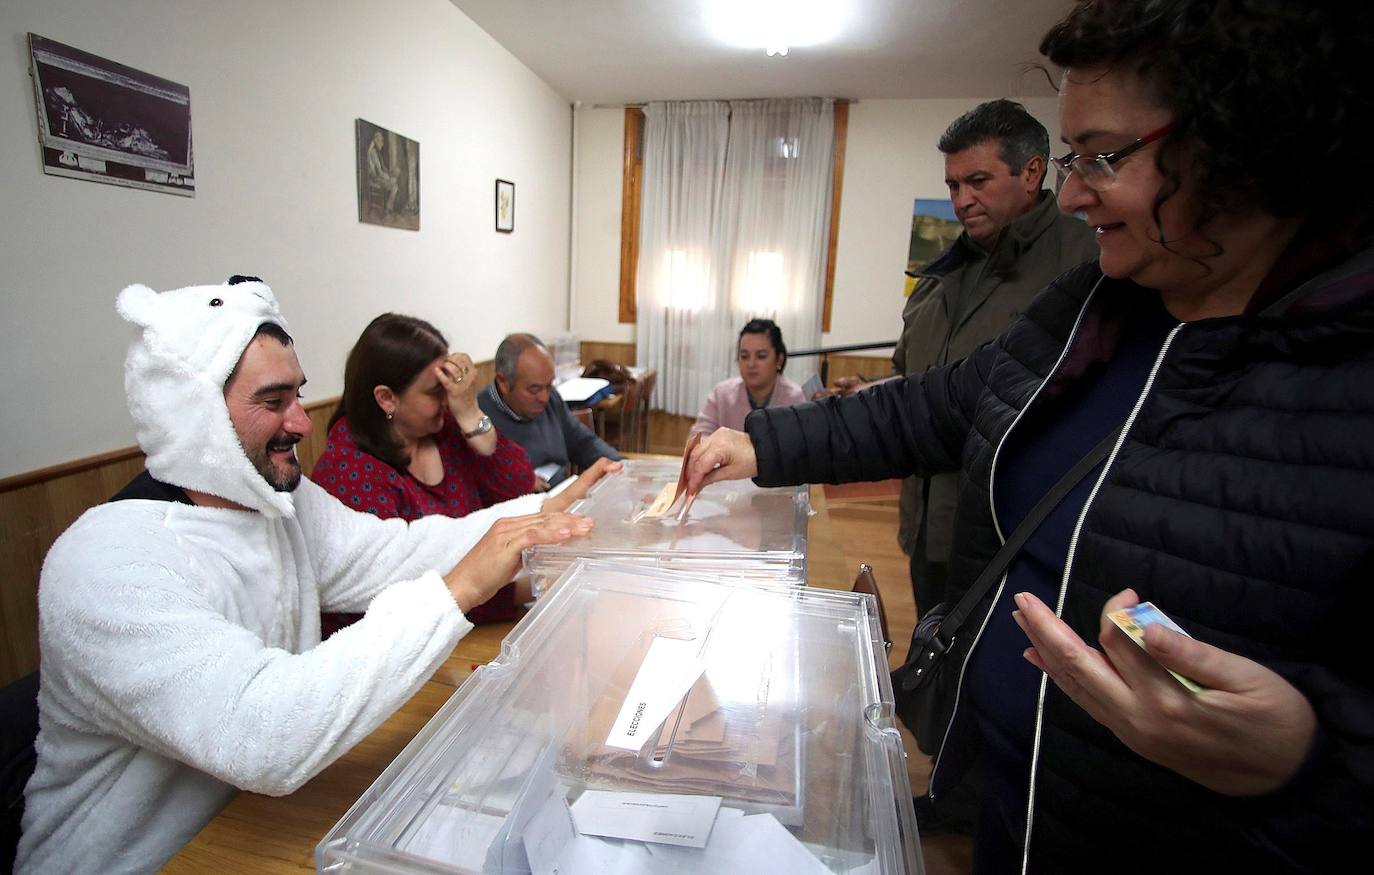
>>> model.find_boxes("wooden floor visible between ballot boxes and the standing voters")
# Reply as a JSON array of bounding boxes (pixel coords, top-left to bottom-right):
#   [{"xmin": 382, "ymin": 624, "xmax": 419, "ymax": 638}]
[{"xmin": 826, "ymin": 481, "xmax": 973, "ymax": 875}]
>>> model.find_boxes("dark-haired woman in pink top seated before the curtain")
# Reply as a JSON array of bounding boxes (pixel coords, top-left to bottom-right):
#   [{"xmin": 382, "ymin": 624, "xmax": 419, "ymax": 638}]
[{"xmin": 691, "ymin": 319, "xmax": 807, "ymax": 435}]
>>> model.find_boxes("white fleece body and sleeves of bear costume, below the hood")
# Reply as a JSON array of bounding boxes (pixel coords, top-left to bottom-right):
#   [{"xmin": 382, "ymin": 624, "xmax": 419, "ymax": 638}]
[{"xmin": 21, "ymin": 481, "xmax": 540, "ymax": 872}]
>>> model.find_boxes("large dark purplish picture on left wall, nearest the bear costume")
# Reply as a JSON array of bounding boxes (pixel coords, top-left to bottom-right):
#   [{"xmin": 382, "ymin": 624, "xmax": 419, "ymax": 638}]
[{"xmin": 29, "ymin": 33, "xmax": 195, "ymax": 198}]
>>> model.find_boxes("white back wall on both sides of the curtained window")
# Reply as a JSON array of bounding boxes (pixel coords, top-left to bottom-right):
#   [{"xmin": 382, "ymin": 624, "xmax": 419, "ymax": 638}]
[{"xmin": 573, "ymin": 98, "xmax": 1059, "ymax": 347}]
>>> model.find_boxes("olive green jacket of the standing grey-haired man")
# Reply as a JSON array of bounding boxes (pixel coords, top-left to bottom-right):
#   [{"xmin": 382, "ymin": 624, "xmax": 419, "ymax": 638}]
[{"xmin": 892, "ymin": 191, "xmax": 1098, "ymax": 562}]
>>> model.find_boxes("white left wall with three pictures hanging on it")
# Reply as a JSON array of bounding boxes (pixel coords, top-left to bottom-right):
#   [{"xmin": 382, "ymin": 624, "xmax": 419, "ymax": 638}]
[{"xmin": 0, "ymin": 0, "xmax": 570, "ymax": 477}]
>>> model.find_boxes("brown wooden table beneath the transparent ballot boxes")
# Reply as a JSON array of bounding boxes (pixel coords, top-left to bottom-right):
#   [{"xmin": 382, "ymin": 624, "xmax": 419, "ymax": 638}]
[{"xmin": 164, "ymin": 486, "xmax": 853, "ymax": 875}]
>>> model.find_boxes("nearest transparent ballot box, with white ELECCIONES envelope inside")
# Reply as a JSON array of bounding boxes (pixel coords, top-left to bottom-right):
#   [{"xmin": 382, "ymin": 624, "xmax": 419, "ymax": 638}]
[{"xmin": 315, "ymin": 560, "xmax": 922, "ymax": 875}]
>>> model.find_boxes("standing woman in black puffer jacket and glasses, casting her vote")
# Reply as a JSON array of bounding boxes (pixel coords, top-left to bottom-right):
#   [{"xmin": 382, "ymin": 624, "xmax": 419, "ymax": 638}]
[{"xmin": 690, "ymin": 0, "xmax": 1374, "ymax": 872}]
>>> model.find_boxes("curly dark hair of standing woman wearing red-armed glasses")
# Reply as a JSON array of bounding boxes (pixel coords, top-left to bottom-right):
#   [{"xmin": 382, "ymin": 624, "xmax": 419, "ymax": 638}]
[{"xmin": 1040, "ymin": 0, "xmax": 1374, "ymax": 237}]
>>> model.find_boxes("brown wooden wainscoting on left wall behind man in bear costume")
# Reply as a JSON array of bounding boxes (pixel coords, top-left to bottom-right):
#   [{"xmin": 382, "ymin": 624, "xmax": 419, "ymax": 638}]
[{"xmin": 0, "ymin": 392, "xmax": 340, "ymax": 685}]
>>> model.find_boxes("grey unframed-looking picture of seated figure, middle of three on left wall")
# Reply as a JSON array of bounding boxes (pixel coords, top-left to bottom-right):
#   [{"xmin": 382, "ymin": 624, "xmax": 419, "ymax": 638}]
[{"xmin": 357, "ymin": 118, "xmax": 420, "ymax": 231}]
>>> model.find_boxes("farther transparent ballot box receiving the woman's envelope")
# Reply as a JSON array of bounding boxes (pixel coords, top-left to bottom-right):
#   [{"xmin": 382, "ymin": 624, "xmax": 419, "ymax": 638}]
[{"xmin": 525, "ymin": 459, "xmax": 811, "ymax": 592}]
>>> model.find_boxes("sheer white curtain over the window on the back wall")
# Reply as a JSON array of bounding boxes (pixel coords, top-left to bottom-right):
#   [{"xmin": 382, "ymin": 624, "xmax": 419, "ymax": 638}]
[{"xmin": 636, "ymin": 99, "xmax": 835, "ymax": 416}]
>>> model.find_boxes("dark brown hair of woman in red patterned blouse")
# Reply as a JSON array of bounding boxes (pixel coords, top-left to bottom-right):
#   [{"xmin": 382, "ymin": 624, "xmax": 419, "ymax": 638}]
[{"xmin": 330, "ymin": 313, "xmax": 448, "ymax": 470}]
